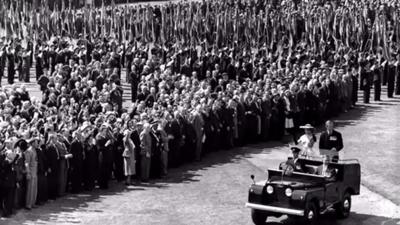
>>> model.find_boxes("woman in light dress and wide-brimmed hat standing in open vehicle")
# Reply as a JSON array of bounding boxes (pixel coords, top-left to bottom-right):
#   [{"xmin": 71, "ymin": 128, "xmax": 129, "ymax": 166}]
[{"xmin": 298, "ymin": 124, "xmax": 319, "ymax": 158}]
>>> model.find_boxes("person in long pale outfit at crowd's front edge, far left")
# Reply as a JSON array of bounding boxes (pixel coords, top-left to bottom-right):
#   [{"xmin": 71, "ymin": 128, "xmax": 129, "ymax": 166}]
[{"xmin": 24, "ymin": 137, "xmax": 39, "ymax": 209}]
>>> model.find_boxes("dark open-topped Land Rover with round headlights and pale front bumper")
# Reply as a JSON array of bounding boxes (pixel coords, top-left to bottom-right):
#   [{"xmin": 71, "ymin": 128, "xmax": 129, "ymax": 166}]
[{"xmin": 246, "ymin": 158, "xmax": 361, "ymax": 225}]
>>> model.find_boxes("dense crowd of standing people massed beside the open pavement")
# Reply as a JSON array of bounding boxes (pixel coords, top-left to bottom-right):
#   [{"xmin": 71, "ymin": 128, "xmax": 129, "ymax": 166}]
[{"xmin": 0, "ymin": 1, "xmax": 400, "ymax": 216}]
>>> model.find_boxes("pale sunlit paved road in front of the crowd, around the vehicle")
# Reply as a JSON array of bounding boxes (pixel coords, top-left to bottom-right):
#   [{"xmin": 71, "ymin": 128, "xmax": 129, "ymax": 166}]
[{"xmin": 0, "ymin": 83, "xmax": 400, "ymax": 225}]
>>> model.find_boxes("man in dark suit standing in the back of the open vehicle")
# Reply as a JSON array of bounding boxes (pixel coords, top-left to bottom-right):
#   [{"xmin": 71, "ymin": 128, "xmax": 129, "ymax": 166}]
[{"xmin": 319, "ymin": 120, "xmax": 343, "ymax": 161}]
